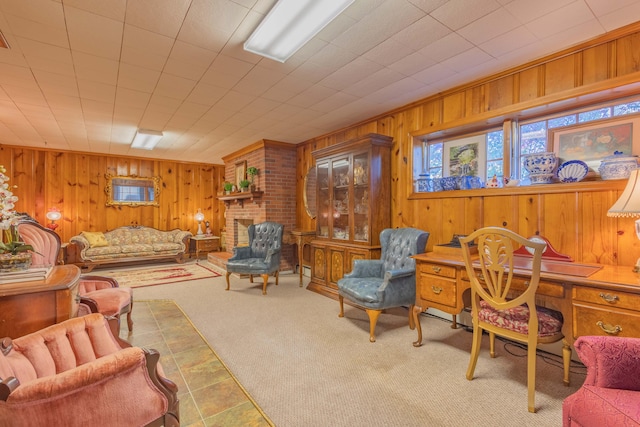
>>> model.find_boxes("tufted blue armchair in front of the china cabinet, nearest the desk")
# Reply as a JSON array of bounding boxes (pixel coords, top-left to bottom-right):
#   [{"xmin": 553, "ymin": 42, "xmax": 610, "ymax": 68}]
[{"xmin": 338, "ymin": 228, "xmax": 429, "ymax": 342}]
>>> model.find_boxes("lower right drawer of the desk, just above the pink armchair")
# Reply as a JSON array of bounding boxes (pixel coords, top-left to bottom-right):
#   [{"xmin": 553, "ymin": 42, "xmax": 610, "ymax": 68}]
[{"xmin": 573, "ymin": 304, "xmax": 640, "ymax": 338}]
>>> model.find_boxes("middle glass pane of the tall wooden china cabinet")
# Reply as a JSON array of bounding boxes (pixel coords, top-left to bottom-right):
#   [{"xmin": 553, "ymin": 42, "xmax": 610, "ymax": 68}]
[{"xmin": 331, "ymin": 156, "xmax": 352, "ymax": 240}]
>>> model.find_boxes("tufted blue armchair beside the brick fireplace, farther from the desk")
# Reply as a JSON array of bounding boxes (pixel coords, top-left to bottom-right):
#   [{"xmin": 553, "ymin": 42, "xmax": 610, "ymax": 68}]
[{"xmin": 226, "ymin": 222, "xmax": 284, "ymax": 295}]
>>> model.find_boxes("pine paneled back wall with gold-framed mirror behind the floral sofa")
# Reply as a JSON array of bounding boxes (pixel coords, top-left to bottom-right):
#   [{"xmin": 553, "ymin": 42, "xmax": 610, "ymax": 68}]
[{"xmin": 0, "ymin": 145, "xmax": 224, "ymax": 242}]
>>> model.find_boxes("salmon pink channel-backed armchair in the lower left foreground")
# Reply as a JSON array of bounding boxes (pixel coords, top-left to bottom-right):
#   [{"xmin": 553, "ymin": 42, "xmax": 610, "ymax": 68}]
[{"xmin": 0, "ymin": 313, "xmax": 180, "ymax": 427}]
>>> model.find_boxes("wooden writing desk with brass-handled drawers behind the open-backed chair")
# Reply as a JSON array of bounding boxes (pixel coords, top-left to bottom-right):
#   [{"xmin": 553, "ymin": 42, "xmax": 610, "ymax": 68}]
[{"xmin": 411, "ymin": 252, "xmax": 640, "ymax": 347}]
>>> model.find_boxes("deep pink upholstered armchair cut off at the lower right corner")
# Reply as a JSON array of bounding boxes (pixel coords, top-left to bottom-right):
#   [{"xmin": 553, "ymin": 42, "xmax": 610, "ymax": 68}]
[{"xmin": 562, "ymin": 336, "xmax": 640, "ymax": 427}]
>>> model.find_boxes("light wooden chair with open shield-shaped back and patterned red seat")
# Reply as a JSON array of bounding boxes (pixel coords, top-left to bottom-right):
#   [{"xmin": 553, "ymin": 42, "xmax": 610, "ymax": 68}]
[{"xmin": 460, "ymin": 227, "xmax": 571, "ymax": 412}]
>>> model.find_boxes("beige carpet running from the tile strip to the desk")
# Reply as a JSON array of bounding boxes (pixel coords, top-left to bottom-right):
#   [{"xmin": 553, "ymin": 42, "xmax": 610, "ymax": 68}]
[{"xmin": 134, "ymin": 268, "xmax": 584, "ymax": 427}]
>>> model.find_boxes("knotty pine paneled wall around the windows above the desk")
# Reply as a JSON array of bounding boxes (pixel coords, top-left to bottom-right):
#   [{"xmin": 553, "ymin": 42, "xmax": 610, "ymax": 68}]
[{"xmin": 297, "ymin": 22, "xmax": 640, "ymax": 265}]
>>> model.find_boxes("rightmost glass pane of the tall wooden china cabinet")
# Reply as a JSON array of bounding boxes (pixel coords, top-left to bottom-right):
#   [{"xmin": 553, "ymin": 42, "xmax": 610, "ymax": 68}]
[{"xmin": 353, "ymin": 153, "xmax": 369, "ymax": 242}]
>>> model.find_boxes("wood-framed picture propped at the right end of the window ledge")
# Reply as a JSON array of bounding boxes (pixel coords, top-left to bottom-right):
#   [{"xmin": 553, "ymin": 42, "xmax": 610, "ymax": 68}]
[{"xmin": 547, "ymin": 117, "xmax": 640, "ymax": 171}]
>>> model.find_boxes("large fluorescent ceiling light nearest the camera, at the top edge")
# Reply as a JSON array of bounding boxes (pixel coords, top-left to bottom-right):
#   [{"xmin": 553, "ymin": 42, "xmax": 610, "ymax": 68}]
[{"xmin": 244, "ymin": 0, "xmax": 354, "ymax": 62}]
